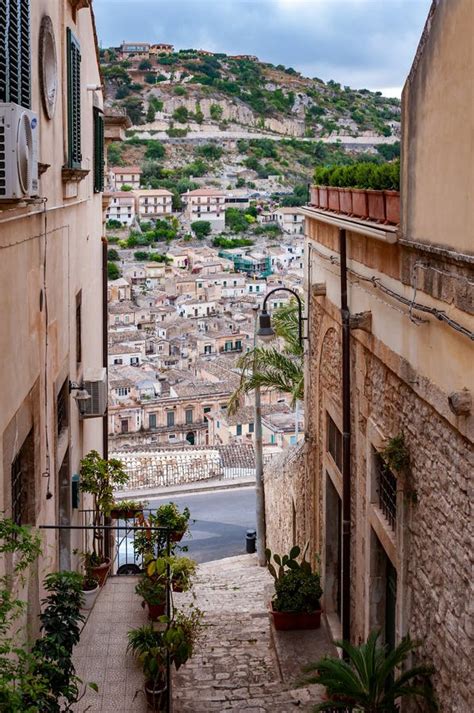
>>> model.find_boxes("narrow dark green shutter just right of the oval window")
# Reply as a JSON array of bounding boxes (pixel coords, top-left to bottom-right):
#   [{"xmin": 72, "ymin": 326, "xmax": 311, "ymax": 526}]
[{"xmin": 67, "ymin": 27, "xmax": 82, "ymax": 168}]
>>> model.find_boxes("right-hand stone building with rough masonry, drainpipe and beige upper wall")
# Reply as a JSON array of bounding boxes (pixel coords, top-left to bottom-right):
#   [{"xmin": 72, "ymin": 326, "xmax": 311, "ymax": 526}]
[{"xmin": 265, "ymin": 0, "xmax": 474, "ymax": 713}]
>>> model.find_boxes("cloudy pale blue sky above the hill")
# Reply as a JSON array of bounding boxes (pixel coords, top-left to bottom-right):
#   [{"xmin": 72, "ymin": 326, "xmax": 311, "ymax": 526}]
[{"xmin": 94, "ymin": 0, "xmax": 431, "ymax": 96}]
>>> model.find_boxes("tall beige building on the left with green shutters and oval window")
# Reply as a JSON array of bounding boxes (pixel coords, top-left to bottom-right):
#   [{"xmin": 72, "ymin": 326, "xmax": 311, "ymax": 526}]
[{"xmin": 0, "ymin": 0, "xmax": 107, "ymax": 633}]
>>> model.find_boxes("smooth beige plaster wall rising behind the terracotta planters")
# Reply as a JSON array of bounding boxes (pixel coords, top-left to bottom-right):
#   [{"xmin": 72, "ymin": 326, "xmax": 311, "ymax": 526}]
[{"xmin": 402, "ymin": 0, "xmax": 474, "ymax": 254}]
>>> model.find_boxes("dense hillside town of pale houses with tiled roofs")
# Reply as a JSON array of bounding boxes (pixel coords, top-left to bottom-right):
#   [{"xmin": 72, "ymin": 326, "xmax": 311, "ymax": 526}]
[{"xmin": 104, "ymin": 167, "xmax": 304, "ymax": 456}]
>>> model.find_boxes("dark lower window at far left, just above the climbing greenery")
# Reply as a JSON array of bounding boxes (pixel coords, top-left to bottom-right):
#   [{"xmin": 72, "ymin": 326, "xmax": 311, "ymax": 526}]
[{"xmin": 11, "ymin": 429, "xmax": 36, "ymax": 525}]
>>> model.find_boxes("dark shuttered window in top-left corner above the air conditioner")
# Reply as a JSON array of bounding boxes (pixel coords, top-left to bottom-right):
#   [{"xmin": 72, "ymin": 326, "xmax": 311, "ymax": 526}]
[{"xmin": 0, "ymin": 0, "xmax": 31, "ymax": 109}]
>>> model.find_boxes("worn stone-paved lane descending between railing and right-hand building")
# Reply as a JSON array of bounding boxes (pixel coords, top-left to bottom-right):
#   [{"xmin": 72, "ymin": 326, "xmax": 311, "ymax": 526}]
[{"xmin": 173, "ymin": 555, "xmax": 332, "ymax": 713}]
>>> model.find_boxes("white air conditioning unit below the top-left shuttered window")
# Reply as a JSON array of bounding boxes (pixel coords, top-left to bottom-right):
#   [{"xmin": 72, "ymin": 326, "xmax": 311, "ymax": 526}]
[{"xmin": 0, "ymin": 102, "xmax": 39, "ymax": 201}]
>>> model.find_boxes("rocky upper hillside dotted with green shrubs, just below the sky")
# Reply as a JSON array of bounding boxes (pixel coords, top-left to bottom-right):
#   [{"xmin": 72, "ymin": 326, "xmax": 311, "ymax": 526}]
[{"xmin": 101, "ymin": 49, "xmax": 400, "ymax": 144}]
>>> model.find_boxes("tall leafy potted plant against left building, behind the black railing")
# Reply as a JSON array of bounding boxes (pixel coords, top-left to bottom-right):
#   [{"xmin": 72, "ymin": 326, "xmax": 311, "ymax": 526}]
[{"xmin": 80, "ymin": 451, "xmax": 128, "ymax": 586}]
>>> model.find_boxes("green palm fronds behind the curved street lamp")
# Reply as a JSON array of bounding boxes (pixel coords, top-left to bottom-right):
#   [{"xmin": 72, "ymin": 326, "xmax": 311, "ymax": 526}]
[{"xmin": 228, "ymin": 300, "xmax": 304, "ymax": 414}]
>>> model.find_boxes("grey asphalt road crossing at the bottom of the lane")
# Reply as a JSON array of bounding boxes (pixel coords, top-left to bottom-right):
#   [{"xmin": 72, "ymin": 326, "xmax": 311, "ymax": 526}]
[{"xmin": 150, "ymin": 487, "xmax": 256, "ymax": 562}]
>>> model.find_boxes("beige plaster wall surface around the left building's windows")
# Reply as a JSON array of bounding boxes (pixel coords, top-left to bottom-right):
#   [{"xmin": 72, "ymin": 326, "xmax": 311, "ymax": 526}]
[{"xmin": 0, "ymin": 0, "xmax": 102, "ymax": 610}]
